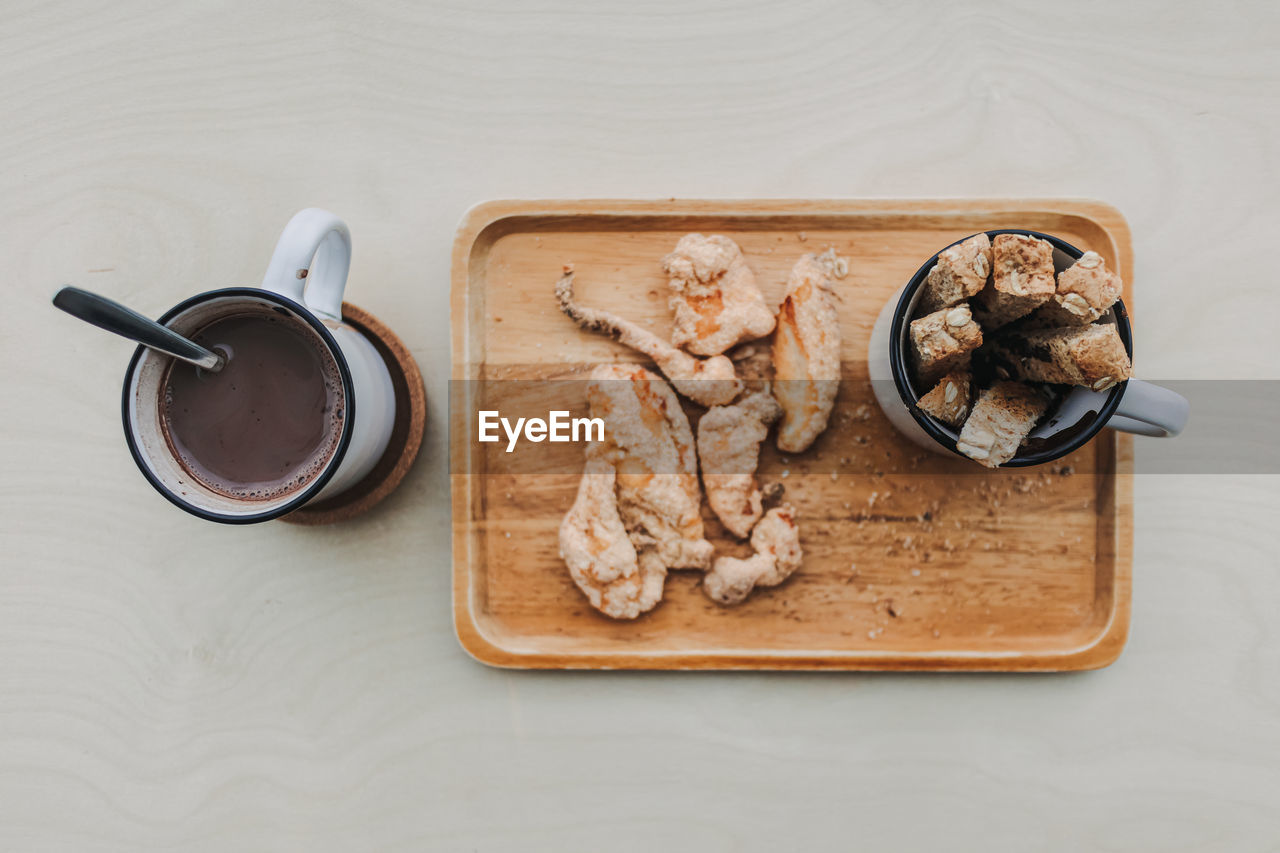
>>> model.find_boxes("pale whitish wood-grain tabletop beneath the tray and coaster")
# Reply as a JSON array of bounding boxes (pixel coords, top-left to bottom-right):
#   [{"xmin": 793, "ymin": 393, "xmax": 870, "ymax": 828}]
[{"xmin": 0, "ymin": 0, "xmax": 1280, "ymax": 853}]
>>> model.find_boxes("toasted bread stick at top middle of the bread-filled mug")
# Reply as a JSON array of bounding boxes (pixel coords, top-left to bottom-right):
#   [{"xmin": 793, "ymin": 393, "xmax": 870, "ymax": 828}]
[{"xmin": 974, "ymin": 234, "xmax": 1057, "ymax": 332}]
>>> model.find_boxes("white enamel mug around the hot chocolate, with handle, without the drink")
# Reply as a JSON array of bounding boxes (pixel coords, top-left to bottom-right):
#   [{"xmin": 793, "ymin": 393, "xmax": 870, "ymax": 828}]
[{"xmin": 122, "ymin": 207, "xmax": 396, "ymax": 524}]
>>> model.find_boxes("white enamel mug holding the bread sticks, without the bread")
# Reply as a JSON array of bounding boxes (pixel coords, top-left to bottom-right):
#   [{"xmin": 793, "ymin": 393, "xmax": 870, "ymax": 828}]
[{"xmin": 867, "ymin": 228, "xmax": 1190, "ymax": 467}]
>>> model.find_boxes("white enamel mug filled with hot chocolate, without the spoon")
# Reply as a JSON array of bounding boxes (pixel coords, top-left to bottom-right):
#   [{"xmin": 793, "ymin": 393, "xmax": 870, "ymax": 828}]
[{"xmin": 123, "ymin": 209, "xmax": 396, "ymax": 524}]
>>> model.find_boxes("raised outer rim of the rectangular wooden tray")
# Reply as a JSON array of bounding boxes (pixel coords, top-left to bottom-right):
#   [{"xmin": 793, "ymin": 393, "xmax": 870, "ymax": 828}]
[{"xmin": 449, "ymin": 197, "xmax": 1133, "ymax": 672}]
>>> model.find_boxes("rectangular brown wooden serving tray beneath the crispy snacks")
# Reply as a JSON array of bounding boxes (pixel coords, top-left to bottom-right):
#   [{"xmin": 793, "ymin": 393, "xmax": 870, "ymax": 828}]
[{"xmin": 451, "ymin": 200, "xmax": 1133, "ymax": 671}]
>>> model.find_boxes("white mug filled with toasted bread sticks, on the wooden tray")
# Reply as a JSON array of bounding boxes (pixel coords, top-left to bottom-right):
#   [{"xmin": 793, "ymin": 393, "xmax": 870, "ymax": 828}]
[{"xmin": 868, "ymin": 228, "xmax": 1189, "ymax": 467}]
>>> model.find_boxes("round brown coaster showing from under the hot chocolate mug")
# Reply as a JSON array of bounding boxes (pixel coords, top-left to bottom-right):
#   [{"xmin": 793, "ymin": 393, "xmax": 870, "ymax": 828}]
[{"xmin": 280, "ymin": 302, "xmax": 426, "ymax": 525}]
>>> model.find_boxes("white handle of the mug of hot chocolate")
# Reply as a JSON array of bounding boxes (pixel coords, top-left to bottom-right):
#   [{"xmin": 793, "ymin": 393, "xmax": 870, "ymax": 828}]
[{"xmin": 262, "ymin": 207, "xmax": 351, "ymax": 323}]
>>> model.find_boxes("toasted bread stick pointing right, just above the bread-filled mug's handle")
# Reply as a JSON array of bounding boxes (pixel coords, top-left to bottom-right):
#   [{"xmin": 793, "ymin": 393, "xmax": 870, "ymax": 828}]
[{"xmin": 996, "ymin": 323, "xmax": 1132, "ymax": 391}]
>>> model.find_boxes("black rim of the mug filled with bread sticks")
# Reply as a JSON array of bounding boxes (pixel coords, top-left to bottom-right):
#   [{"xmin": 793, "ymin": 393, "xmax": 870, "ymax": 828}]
[{"xmin": 888, "ymin": 228, "xmax": 1133, "ymax": 467}]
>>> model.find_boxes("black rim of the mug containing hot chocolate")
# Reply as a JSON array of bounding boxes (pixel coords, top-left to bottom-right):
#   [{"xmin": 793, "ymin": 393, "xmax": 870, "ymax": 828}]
[{"xmin": 120, "ymin": 287, "xmax": 356, "ymax": 524}]
